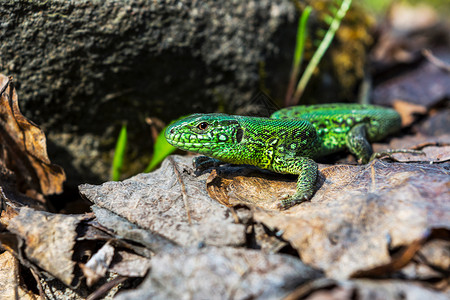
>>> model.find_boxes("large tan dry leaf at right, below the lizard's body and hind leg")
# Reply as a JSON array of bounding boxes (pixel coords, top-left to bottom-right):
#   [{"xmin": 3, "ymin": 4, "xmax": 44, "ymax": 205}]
[{"xmin": 254, "ymin": 161, "xmax": 450, "ymax": 278}]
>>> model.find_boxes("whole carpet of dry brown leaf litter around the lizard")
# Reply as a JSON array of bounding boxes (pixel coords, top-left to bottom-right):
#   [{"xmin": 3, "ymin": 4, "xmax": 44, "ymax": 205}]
[{"xmin": 0, "ymin": 1, "xmax": 450, "ymax": 299}]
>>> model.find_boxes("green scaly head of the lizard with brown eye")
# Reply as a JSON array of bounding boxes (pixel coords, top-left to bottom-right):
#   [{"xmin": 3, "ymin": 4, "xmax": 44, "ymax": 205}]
[{"xmin": 165, "ymin": 114, "xmax": 243, "ymax": 155}]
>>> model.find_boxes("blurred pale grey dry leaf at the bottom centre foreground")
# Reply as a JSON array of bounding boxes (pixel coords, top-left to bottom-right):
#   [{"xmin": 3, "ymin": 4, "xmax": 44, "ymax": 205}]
[{"xmin": 116, "ymin": 247, "xmax": 322, "ymax": 300}]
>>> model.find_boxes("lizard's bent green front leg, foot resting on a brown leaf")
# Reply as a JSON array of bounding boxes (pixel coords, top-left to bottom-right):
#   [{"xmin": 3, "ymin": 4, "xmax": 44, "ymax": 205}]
[{"xmin": 276, "ymin": 157, "xmax": 318, "ymax": 209}]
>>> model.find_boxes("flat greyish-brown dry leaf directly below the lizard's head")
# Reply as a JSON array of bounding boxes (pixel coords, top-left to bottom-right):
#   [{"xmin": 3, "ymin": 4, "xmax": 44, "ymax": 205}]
[{"xmin": 79, "ymin": 156, "xmax": 246, "ymax": 247}]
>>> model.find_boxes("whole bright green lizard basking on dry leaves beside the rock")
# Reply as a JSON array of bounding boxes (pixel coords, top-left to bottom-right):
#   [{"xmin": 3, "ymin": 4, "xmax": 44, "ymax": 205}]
[{"xmin": 165, "ymin": 104, "xmax": 401, "ymax": 208}]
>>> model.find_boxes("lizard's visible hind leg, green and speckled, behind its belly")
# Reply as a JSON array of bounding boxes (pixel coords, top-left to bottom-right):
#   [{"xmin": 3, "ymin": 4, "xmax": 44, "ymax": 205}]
[{"xmin": 345, "ymin": 124, "xmax": 373, "ymax": 164}]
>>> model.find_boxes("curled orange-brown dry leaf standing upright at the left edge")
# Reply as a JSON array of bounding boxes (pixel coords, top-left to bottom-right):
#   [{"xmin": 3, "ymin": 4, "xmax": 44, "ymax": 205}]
[{"xmin": 0, "ymin": 74, "xmax": 66, "ymax": 195}]
